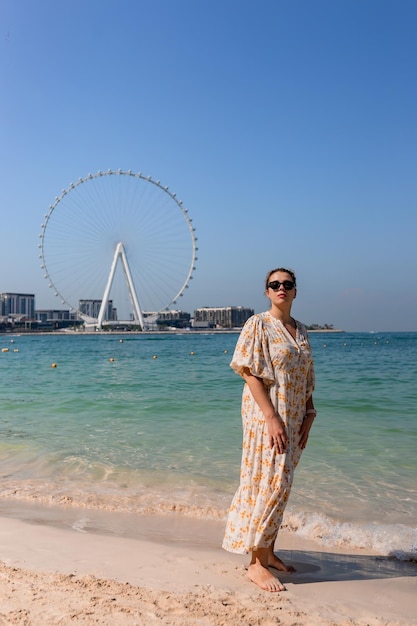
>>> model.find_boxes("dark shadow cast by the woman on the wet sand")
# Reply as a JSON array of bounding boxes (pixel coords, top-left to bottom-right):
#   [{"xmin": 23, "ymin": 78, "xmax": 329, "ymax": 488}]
[{"xmin": 271, "ymin": 550, "xmax": 417, "ymax": 585}]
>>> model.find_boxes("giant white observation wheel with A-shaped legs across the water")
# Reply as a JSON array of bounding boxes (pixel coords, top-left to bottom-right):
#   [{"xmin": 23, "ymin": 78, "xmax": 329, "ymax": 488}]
[{"xmin": 39, "ymin": 170, "xmax": 197, "ymax": 329}]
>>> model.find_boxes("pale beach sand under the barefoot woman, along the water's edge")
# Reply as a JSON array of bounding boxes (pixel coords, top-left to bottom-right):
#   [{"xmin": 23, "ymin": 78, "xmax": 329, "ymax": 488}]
[{"xmin": 0, "ymin": 500, "xmax": 417, "ymax": 626}]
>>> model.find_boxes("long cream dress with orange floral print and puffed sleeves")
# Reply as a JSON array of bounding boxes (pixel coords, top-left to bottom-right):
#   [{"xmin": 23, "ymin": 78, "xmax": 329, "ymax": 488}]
[{"xmin": 223, "ymin": 313, "xmax": 314, "ymax": 554}]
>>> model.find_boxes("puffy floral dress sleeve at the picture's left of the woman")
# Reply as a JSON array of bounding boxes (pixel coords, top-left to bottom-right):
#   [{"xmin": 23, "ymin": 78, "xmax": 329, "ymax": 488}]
[{"xmin": 230, "ymin": 315, "xmax": 275, "ymax": 384}]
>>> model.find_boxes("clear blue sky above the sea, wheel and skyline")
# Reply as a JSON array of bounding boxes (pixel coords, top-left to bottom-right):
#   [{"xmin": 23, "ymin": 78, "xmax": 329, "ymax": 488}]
[{"xmin": 0, "ymin": 0, "xmax": 417, "ymax": 331}]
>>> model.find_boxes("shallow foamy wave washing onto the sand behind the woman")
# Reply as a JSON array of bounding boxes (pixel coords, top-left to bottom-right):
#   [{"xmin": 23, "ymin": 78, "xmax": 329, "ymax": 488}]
[{"xmin": 1, "ymin": 480, "xmax": 417, "ymax": 561}]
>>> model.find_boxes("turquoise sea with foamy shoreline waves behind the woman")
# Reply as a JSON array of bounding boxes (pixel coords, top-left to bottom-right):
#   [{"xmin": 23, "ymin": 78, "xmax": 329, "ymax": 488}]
[{"xmin": 0, "ymin": 333, "xmax": 417, "ymax": 559}]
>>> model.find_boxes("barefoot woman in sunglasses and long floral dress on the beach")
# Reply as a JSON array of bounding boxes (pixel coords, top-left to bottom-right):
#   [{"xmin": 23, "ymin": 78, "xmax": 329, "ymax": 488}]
[{"xmin": 223, "ymin": 267, "xmax": 316, "ymax": 591}]
